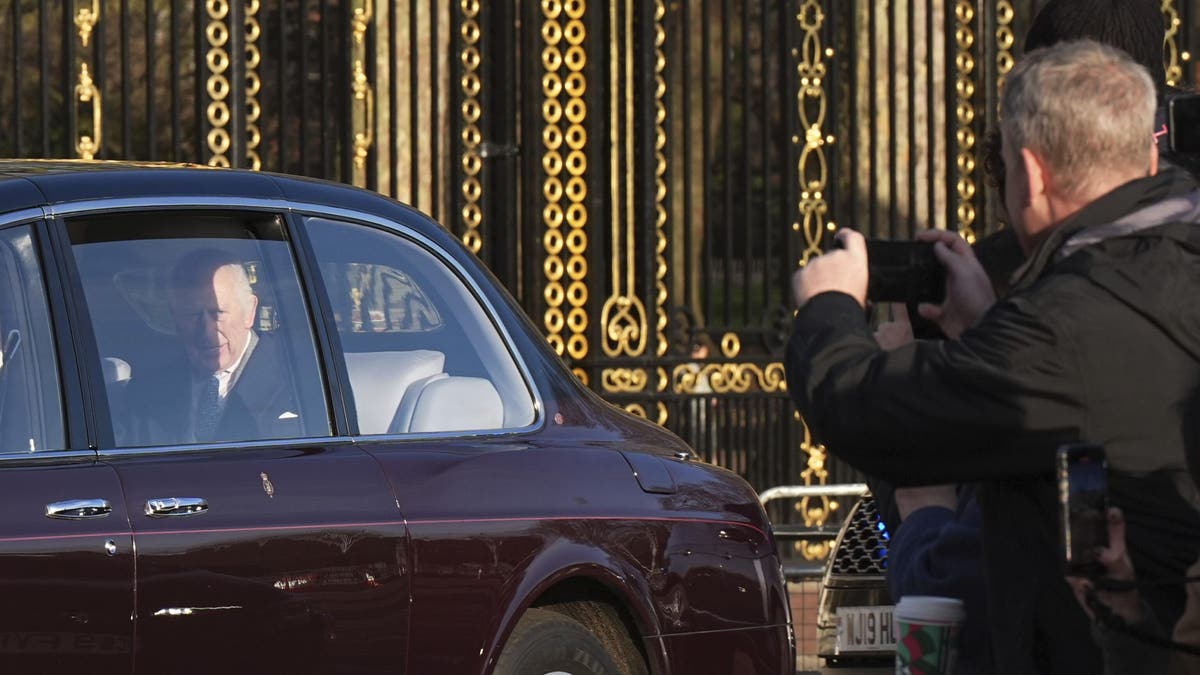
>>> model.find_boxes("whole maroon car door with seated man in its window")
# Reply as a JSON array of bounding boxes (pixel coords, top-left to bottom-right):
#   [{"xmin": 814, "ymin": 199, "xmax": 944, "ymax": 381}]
[{"xmin": 65, "ymin": 208, "xmax": 417, "ymax": 674}]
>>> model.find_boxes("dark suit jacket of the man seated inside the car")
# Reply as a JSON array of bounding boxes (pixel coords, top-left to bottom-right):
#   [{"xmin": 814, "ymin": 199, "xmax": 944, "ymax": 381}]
[{"xmin": 125, "ymin": 335, "xmax": 302, "ymax": 446}]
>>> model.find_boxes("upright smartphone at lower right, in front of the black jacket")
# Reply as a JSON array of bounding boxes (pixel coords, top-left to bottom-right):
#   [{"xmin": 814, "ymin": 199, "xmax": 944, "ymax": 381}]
[{"xmin": 1058, "ymin": 443, "xmax": 1109, "ymax": 577}]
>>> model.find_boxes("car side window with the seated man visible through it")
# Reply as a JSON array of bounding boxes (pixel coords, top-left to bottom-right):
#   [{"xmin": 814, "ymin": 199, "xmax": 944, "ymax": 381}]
[{"xmin": 67, "ymin": 211, "xmax": 331, "ymax": 447}]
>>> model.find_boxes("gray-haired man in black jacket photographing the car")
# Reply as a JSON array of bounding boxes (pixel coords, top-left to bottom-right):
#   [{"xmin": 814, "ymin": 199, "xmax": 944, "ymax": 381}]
[{"xmin": 787, "ymin": 42, "xmax": 1200, "ymax": 673}]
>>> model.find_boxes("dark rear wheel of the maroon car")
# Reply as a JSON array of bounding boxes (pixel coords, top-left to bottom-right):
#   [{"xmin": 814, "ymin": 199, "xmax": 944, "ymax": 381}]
[{"xmin": 493, "ymin": 609, "xmax": 622, "ymax": 675}]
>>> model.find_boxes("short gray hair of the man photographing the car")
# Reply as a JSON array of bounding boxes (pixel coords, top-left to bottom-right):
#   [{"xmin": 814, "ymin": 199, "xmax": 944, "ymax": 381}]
[{"xmin": 1000, "ymin": 40, "xmax": 1156, "ymax": 196}]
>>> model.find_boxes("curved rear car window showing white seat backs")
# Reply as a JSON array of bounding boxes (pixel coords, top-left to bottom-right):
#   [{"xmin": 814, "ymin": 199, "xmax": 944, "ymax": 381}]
[{"xmin": 306, "ymin": 217, "xmax": 534, "ymax": 435}]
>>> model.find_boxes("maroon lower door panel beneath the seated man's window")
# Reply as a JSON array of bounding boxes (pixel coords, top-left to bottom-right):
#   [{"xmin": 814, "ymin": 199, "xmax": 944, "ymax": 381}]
[{"xmin": 109, "ymin": 446, "xmax": 408, "ymax": 673}]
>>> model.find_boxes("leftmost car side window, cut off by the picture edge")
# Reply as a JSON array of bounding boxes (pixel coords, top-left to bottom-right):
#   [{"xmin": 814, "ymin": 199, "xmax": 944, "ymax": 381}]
[{"xmin": 0, "ymin": 226, "xmax": 66, "ymax": 453}]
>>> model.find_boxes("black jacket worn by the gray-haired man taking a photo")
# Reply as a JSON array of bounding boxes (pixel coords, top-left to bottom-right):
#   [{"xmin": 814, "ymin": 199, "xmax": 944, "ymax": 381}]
[{"xmin": 787, "ymin": 171, "xmax": 1200, "ymax": 673}]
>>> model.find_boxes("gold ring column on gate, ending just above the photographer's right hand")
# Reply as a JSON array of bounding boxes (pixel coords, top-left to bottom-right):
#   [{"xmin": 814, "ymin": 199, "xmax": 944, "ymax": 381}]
[{"xmin": 954, "ymin": 0, "xmax": 976, "ymax": 244}]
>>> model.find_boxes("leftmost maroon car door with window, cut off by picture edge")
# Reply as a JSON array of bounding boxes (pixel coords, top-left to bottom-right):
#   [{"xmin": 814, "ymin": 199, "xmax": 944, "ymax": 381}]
[{"xmin": 0, "ymin": 222, "xmax": 133, "ymax": 673}]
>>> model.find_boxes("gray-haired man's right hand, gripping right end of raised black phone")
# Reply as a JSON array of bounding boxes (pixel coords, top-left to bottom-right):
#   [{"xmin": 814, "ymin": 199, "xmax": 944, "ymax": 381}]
[{"xmin": 917, "ymin": 229, "xmax": 996, "ymax": 340}]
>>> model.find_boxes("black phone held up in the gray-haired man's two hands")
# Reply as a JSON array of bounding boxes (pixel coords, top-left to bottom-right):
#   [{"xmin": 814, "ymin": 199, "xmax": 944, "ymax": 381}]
[{"xmin": 866, "ymin": 239, "xmax": 946, "ymax": 300}]
